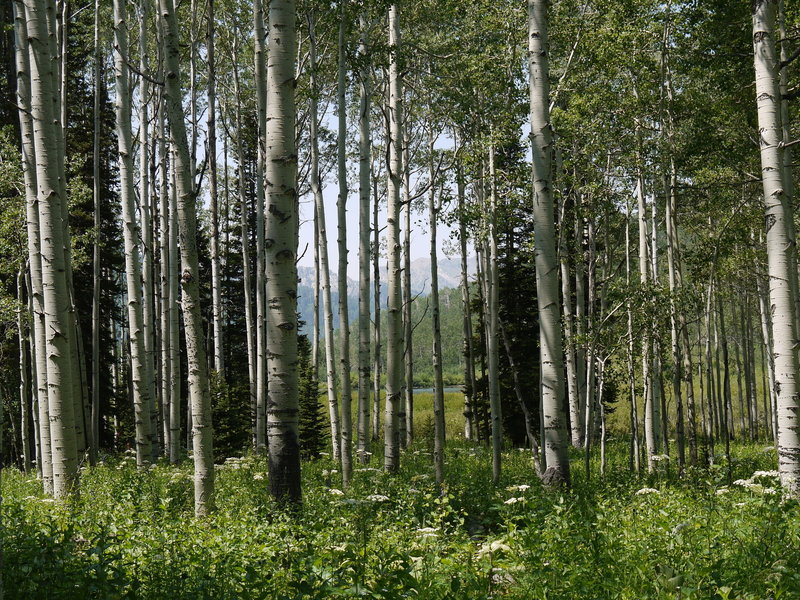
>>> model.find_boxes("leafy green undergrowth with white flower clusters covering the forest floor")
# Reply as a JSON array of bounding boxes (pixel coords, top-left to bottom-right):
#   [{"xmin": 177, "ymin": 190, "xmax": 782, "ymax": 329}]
[{"xmin": 0, "ymin": 443, "xmax": 800, "ymax": 600}]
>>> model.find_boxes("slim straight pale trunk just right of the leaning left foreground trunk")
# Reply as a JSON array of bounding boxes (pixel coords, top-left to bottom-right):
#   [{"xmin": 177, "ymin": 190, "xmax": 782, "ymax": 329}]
[{"xmin": 206, "ymin": 0, "xmax": 227, "ymax": 378}]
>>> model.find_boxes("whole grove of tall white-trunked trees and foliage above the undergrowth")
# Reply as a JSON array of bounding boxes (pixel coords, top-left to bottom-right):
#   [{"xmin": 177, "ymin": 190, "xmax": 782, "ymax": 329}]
[{"xmin": 0, "ymin": 0, "xmax": 800, "ymax": 597}]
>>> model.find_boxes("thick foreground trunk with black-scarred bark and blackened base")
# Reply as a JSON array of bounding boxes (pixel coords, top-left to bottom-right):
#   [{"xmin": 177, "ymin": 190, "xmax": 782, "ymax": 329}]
[{"xmin": 264, "ymin": 0, "xmax": 301, "ymax": 502}]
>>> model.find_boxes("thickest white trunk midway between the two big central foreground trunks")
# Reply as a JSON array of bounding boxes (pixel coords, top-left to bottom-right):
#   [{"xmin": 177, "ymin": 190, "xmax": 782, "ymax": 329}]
[{"xmin": 383, "ymin": 4, "xmax": 403, "ymax": 472}]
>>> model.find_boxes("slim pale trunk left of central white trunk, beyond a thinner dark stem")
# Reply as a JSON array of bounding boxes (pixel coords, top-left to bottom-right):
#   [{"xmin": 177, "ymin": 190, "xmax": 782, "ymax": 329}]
[{"xmin": 356, "ymin": 15, "xmax": 372, "ymax": 463}]
